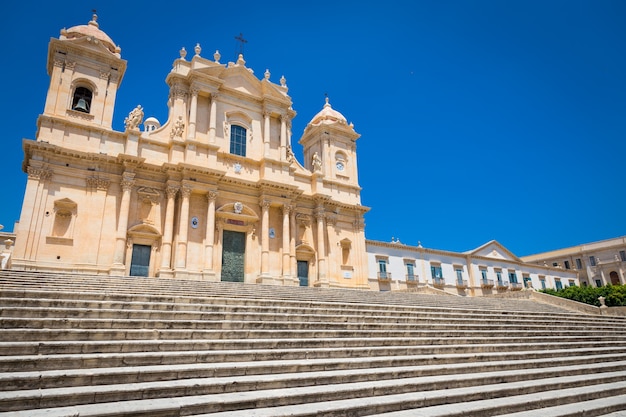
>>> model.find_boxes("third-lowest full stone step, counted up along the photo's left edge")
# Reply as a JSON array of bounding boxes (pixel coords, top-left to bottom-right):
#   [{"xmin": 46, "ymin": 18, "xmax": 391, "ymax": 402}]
[{"xmin": 0, "ymin": 345, "xmax": 626, "ymax": 373}]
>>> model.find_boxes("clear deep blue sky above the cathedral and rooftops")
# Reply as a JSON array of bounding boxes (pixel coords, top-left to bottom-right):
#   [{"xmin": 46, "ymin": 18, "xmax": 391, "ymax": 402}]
[{"xmin": 0, "ymin": 0, "xmax": 626, "ymax": 256}]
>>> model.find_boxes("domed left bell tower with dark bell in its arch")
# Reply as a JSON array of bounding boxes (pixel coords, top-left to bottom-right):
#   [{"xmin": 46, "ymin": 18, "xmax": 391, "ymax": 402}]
[{"xmin": 40, "ymin": 13, "xmax": 126, "ymax": 129}]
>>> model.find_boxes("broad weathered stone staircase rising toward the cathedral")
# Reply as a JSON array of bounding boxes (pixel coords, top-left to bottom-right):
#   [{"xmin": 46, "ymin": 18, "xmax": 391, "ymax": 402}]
[{"xmin": 0, "ymin": 271, "xmax": 626, "ymax": 417}]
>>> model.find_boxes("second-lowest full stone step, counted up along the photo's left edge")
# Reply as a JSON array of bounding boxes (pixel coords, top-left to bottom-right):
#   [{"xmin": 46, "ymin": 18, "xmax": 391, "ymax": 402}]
[{"xmin": 0, "ymin": 353, "xmax": 626, "ymax": 391}]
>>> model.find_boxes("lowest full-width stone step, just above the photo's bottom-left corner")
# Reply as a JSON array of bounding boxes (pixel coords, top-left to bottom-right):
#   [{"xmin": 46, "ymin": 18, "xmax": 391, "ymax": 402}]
[{"xmin": 0, "ymin": 361, "xmax": 626, "ymax": 411}]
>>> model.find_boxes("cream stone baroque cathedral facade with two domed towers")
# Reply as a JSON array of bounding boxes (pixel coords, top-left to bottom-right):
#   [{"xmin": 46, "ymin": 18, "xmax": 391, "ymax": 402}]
[{"xmin": 12, "ymin": 15, "xmax": 369, "ymax": 289}]
